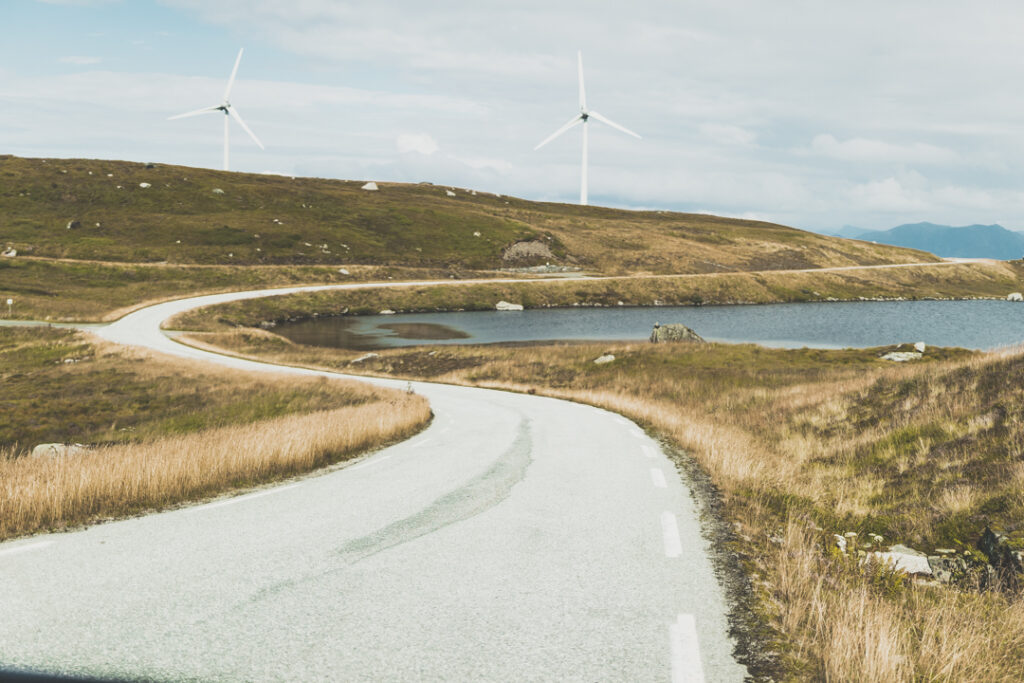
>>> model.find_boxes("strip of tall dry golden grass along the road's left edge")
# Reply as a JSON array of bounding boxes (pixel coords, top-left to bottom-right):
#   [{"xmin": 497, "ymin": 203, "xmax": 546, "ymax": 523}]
[{"xmin": 0, "ymin": 392, "xmax": 430, "ymax": 540}]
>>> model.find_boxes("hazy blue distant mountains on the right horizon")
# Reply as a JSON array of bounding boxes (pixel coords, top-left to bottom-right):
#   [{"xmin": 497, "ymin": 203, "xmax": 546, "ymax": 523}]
[{"xmin": 834, "ymin": 223, "xmax": 1024, "ymax": 260}]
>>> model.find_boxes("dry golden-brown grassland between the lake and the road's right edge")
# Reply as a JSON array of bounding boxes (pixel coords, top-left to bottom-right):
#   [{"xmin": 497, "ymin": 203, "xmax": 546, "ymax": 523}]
[{"xmin": 188, "ymin": 333, "xmax": 1024, "ymax": 681}]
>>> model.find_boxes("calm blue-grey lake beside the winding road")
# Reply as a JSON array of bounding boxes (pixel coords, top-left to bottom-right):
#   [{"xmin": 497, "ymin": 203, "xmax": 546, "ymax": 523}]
[{"xmin": 274, "ymin": 301, "xmax": 1024, "ymax": 349}]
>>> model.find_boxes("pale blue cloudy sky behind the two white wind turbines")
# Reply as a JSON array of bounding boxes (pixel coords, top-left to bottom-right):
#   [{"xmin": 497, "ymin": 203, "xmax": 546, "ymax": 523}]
[{"xmin": 0, "ymin": 0, "xmax": 1024, "ymax": 231}]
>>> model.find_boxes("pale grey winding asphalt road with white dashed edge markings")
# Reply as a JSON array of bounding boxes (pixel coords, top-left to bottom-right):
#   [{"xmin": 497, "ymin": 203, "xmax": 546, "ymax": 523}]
[{"xmin": 0, "ymin": 288, "xmax": 745, "ymax": 681}]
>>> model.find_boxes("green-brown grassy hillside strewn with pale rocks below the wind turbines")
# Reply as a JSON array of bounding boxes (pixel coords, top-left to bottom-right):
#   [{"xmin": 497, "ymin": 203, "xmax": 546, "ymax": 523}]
[{"xmin": 0, "ymin": 156, "xmax": 935, "ymax": 273}]
